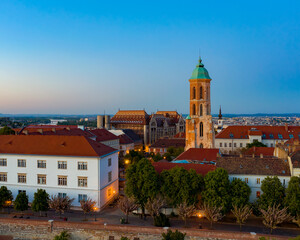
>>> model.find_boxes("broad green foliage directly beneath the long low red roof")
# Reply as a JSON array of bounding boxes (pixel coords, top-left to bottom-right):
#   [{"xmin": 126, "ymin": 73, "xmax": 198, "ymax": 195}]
[{"xmin": 161, "ymin": 167, "xmax": 204, "ymax": 207}]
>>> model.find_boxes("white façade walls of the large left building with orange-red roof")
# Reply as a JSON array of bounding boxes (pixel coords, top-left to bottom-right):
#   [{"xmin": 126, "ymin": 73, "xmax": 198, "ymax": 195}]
[{"xmin": 0, "ymin": 153, "xmax": 118, "ymax": 208}]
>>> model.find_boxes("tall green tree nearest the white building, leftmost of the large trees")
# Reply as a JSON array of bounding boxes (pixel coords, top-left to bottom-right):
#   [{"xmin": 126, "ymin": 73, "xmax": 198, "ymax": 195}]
[{"xmin": 125, "ymin": 158, "xmax": 159, "ymax": 216}]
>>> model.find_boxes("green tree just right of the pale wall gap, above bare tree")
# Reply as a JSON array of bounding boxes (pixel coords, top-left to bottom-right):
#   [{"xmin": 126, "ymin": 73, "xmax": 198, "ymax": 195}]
[{"xmin": 258, "ymin": 176, "xmax": 285, "ymax": 210}]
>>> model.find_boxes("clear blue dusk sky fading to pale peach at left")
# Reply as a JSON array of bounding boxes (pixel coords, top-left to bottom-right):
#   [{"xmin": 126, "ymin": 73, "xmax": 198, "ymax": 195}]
[{"xmin": 0, "ymin": 0, "xmax": 300, "ymax": 114}]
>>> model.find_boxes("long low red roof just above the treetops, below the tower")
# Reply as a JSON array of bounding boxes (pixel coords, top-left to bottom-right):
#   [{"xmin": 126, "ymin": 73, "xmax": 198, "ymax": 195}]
[{"xmin": 152, "ymin": 162, "xmax": 216, "ymax": 176}]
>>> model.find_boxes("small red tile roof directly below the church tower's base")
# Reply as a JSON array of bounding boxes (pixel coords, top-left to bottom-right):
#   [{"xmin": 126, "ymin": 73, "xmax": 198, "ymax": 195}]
[{"xmin": 175, "ymin": 148, "xmax": 219, "ymax": 162}]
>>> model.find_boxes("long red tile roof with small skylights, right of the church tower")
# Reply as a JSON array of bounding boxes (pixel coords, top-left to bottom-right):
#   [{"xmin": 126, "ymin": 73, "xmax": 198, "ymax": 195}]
[{"xmin": 216, "ymin": 126, "xmax": 300, "ymax": 139}]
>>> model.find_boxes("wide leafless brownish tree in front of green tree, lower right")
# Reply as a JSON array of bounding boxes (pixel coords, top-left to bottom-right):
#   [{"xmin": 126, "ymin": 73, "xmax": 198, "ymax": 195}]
[{"xmin": 260, "ymin": 204, "xmax": 292, "ymax": 234}]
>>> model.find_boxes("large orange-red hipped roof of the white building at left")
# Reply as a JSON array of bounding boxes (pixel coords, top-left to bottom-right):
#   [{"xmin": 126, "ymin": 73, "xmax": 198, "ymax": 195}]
[{"xmin": 0, "ymin": 135, "xmax": 116, "ymax": 157}]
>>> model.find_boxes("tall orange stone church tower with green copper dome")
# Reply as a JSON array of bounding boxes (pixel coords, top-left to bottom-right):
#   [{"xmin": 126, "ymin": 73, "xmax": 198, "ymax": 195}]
[{"xmin": 185, "ymin": 58, "xmax": 214, "ymax": 150}]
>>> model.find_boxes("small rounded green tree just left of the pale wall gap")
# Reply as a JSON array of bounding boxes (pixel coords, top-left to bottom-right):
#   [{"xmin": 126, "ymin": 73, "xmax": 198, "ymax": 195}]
[{"xmin": 230, "ymin": 179, "xmax": 251, "ymax": 207}]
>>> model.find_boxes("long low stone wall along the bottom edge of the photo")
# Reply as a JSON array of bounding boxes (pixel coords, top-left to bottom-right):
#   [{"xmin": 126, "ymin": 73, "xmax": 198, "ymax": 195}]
[{"xmin": 0, "ymin": 218, "xmax": 288, "ymax": 240}]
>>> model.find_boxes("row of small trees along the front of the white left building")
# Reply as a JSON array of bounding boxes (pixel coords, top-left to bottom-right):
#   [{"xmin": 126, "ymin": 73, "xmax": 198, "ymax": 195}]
[{"xmin": 0, "ymin": 186, "xmax": 96, "ymax": 219}]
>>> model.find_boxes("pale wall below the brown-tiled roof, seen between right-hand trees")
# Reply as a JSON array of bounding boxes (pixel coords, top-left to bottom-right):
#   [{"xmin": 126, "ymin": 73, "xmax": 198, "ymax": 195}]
[{"xmin": 229, "ymin": 174, "xmax": 290, "ymax": 203}]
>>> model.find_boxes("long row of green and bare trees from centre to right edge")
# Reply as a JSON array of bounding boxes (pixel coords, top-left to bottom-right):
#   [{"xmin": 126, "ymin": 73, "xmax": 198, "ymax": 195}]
[{"xmin": 125, "ymin": 159, "xmax": 300, "ymax": 233}]
